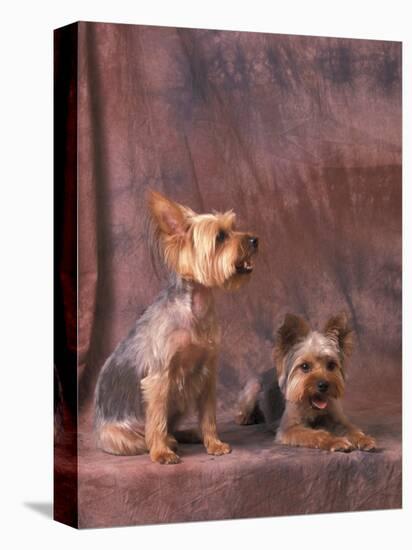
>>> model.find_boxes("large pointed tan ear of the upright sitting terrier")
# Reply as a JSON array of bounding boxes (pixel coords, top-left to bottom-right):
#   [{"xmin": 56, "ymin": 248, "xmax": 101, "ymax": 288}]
[{"xmin": 148, "ymin": 190, "xmax": 193, "ymax": 236}]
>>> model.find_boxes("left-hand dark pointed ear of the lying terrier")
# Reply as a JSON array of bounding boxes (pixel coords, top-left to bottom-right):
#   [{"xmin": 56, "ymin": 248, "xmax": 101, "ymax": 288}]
[{"xmin": 273, "ymin": 313, "xmax": 310, "ymax": 389}]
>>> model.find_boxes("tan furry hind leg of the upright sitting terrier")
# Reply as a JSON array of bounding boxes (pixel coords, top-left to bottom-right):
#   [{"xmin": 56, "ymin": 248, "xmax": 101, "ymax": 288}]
[{"xmin": 97, "ymin": 423, "xmax": 148, "ymax": 455}]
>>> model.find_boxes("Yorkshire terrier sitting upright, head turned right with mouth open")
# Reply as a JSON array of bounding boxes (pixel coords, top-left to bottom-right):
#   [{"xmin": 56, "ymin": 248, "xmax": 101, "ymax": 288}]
[{"xmin": 95, "ymin": 191, "xmax": 258, "ymax": 464}]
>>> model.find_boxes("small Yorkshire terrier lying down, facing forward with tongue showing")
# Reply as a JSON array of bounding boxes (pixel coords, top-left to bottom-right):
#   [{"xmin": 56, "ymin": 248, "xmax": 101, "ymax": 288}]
[{"xmin": 236, "ymin": 313, "xmax": 376, "ymax": 452}]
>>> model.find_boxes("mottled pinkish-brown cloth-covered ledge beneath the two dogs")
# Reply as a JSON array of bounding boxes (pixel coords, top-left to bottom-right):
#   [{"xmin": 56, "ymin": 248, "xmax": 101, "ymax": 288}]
[{"xmin": 53, "ymin": 407, "xmax": 402, "ymax": 527}]
